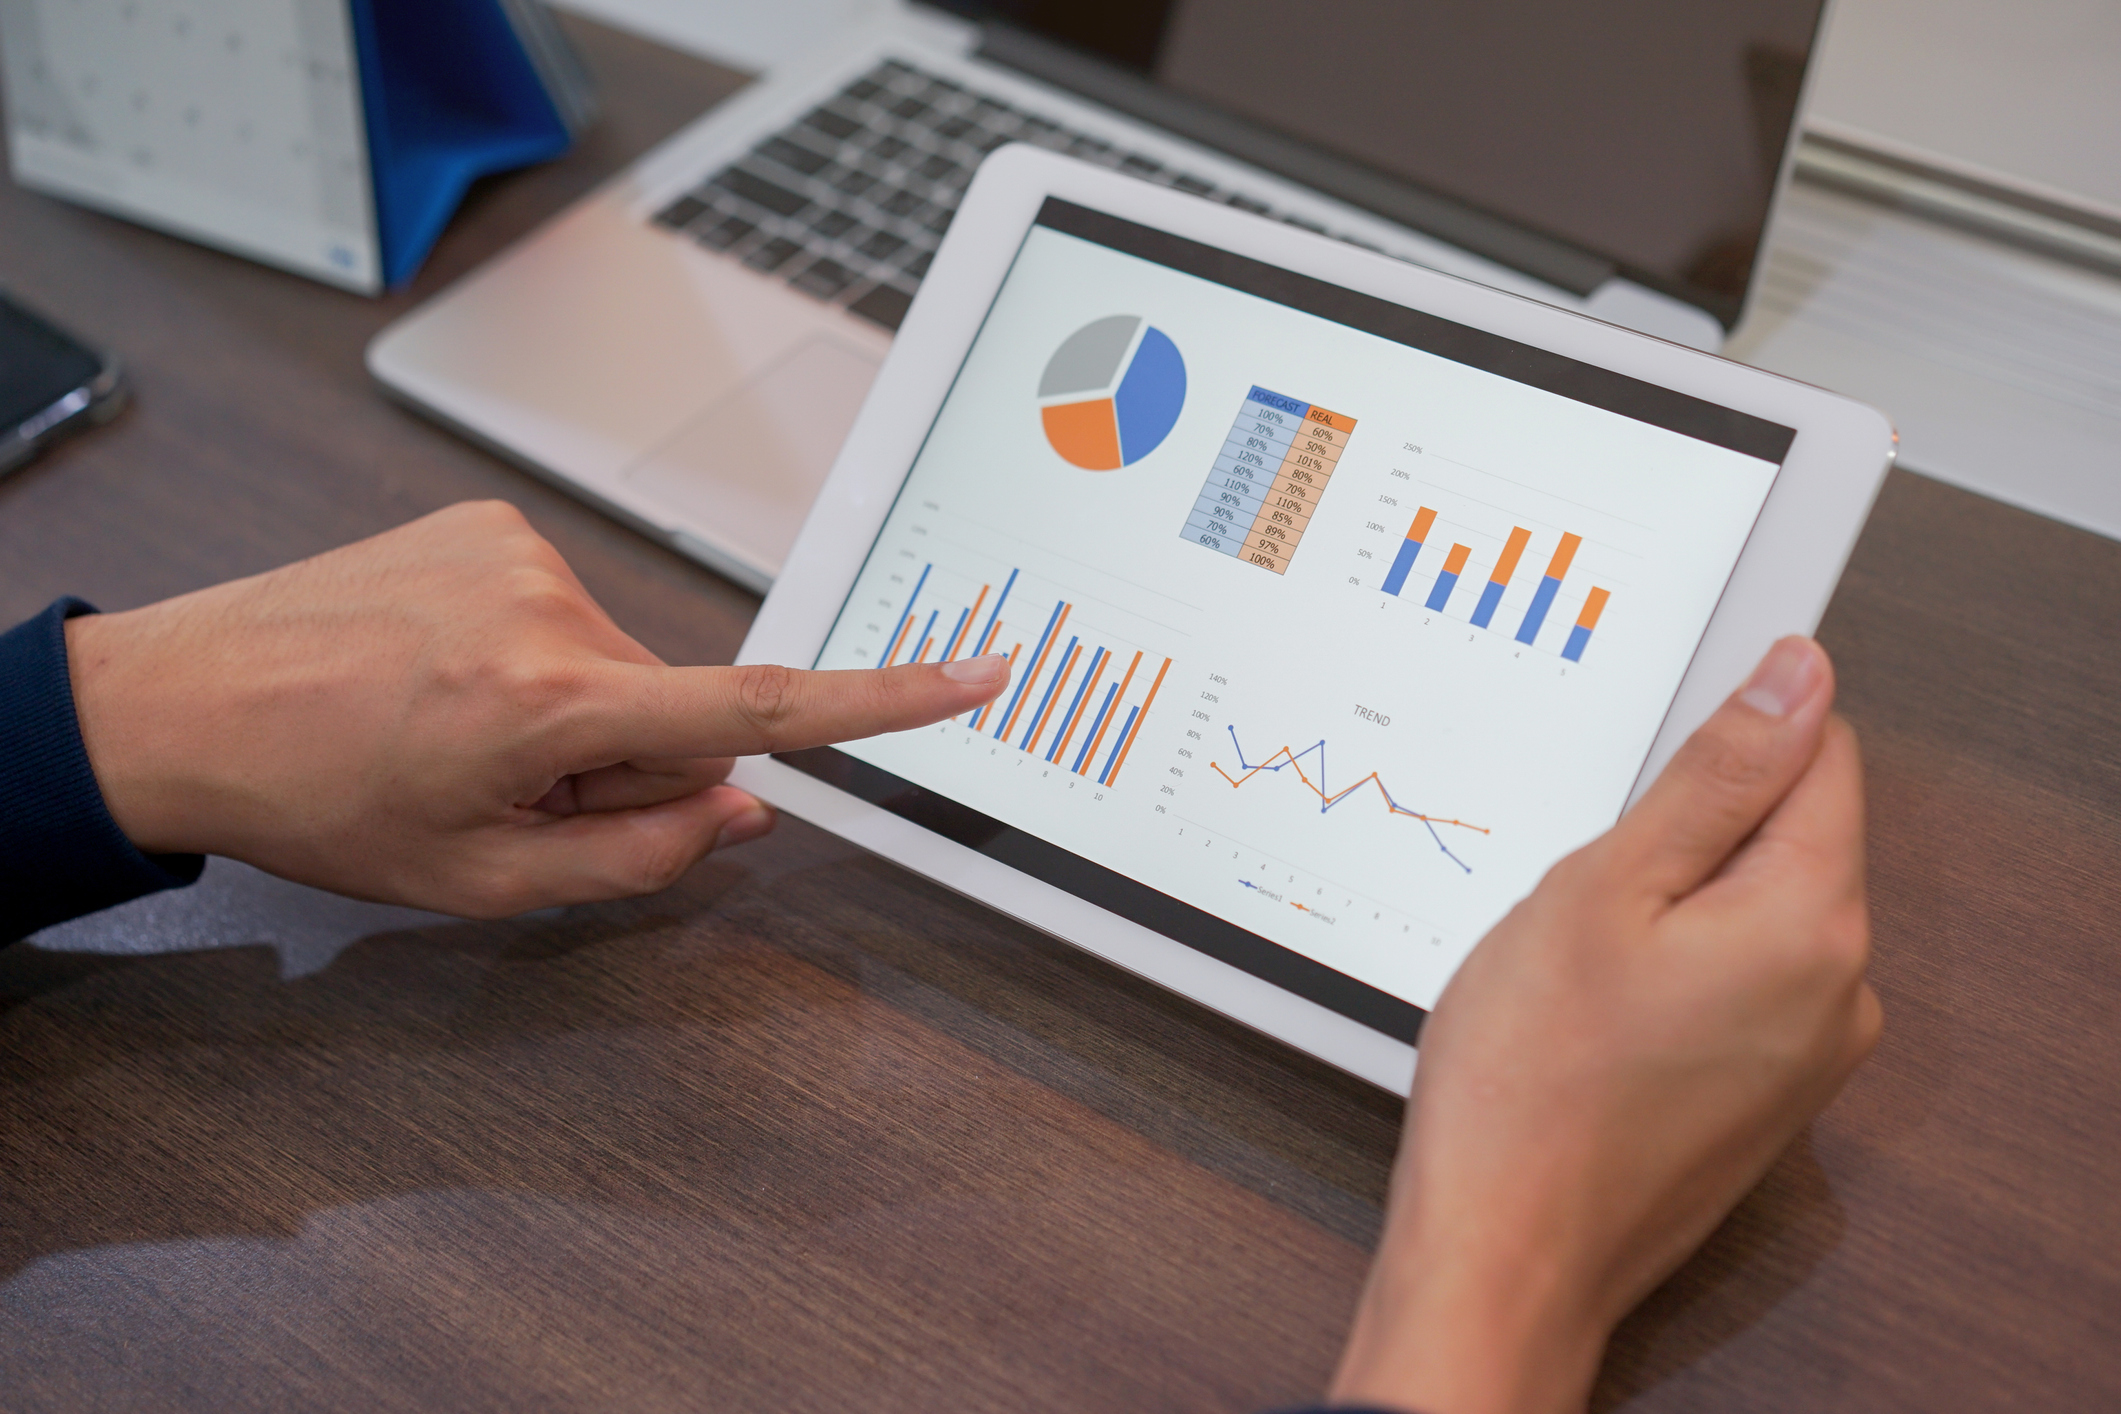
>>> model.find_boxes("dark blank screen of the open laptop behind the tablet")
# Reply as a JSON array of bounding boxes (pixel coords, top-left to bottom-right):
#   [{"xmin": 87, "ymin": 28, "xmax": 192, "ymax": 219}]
[{"xmin": 950, "ymin": 0, "xmax": 1822, "ymax": 322}]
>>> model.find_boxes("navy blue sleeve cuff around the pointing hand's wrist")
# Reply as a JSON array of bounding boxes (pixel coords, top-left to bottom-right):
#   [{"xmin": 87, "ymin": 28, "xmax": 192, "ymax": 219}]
[{"xmin": 0, "ymin": 598, "xmax": 206, "ymax": 941}]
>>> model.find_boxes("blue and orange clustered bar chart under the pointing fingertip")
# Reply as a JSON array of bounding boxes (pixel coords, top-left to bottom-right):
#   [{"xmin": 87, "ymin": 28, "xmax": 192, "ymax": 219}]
[{"xmin": 876, "ymin": 562, "xmax": 1171, "ymax": 786}]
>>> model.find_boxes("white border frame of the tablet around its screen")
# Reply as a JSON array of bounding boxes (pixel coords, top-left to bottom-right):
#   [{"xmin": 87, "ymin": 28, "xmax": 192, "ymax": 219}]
[{"xmin": 732, "ymin": 144, "xmax": 1896, "ymax": 1094}]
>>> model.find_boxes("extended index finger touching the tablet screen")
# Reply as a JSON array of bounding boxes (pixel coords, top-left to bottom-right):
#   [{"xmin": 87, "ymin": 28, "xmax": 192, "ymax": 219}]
[{"xmin": 581, "ymin": 653, "xmax": 1010, "ymax": 761}]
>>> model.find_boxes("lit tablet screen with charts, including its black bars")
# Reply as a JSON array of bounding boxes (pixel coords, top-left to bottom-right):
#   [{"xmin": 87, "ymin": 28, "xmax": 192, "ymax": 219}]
[{"xmin": 783, "ymin": 199, "xmax": 1794, "ymax": 1039}]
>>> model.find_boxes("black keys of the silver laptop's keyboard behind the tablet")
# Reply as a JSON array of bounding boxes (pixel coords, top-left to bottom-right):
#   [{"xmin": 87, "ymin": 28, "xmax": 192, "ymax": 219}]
[{"xmin": 655, "ymin": 59, "xmax": 1377, "ymax": 331}]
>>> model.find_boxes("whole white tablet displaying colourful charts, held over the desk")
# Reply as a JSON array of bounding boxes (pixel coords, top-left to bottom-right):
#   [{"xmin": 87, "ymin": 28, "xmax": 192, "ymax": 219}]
[{"xmin": 734, "ymin": 146, "xmax": 1894, "ymax": 1092}]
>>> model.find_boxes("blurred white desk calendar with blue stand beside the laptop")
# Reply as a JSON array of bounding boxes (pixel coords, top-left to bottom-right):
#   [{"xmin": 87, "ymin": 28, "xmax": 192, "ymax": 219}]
[{"xmin": 0, "ymin": 0, "xmax": 592, "ymax": 293}]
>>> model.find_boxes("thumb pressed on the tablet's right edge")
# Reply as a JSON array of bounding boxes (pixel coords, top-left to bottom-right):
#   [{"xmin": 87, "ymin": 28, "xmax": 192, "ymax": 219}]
[{"xmin": 1612, "ymin": 638, "xmax": 1835, "ymax": 899}]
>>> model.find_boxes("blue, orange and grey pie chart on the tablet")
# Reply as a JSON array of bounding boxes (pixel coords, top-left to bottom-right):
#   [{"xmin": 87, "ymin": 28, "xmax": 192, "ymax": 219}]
[{"xmin": 1039, "ymin": 314, "xmax": 1186, "ymax": 471}]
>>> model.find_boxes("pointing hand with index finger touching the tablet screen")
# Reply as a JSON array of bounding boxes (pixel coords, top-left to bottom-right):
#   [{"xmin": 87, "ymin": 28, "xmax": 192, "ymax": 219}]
[{"xmin": 66, "ymin": 502, "xmax": 1007, "ymax": 918}]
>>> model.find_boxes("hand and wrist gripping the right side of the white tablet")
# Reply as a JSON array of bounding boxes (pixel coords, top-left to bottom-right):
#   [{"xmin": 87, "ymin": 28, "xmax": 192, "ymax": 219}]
[{"xmin": 1332, "ymin": 638, "xmax": 1879, "ymax": 1414}]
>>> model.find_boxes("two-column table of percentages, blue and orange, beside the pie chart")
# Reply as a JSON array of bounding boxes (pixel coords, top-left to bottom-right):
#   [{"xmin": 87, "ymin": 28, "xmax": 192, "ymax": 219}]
[{"xmin": 1184, "ymin": 388, "xmax": 1355, "ymax": 575}]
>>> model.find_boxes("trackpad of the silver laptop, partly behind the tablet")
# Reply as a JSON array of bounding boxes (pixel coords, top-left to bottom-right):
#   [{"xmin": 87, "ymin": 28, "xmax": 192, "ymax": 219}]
[{"xmin": 626, "ymin": 337, "xmax": 878, "ymax": 575}]
